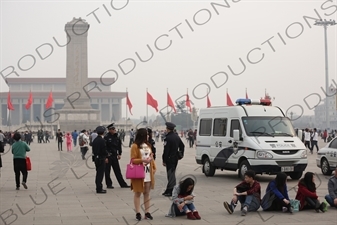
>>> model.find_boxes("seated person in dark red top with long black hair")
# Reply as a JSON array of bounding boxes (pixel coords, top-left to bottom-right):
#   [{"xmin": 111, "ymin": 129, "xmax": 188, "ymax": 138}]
[{"xmin": 296, "ymin": 172, "xmax": 326, "ymax": 212}]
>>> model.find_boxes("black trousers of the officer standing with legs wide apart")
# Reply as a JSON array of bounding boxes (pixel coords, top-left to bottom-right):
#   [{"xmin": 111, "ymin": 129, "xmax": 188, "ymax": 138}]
[{"xmin": 105, "ymin": 156, "xmax": 128, "ymax": 187}]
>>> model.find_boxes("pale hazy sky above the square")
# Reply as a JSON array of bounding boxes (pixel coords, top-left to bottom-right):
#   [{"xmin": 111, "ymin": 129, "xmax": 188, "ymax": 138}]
[{"xmin": 0, "ymin": 0, "xmax": 337, "ymax": 118}]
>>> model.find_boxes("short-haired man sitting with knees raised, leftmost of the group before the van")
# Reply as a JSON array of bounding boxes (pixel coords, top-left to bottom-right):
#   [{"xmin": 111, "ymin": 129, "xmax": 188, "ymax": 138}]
[{"xmin": 224, "ymin": 170, "xmax": 261, "ymax": 216}]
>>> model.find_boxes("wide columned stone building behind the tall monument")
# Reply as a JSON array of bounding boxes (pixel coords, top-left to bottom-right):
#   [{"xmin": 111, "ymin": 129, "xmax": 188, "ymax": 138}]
[{"xmin": 0, "ymin": 78, "xmax": 126, "ymax": 129}]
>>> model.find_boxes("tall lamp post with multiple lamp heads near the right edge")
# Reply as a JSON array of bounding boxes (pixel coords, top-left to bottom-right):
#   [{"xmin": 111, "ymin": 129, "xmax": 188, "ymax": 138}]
[{"xmin": 314, "ymin": 19, "xmax": 336, "ymax": 129}]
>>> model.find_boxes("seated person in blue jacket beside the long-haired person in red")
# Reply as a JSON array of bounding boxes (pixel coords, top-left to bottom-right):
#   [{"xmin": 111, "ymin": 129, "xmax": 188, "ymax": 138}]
[{"xmin": 261, "ymin": 173, "xmax": 293, "ymax": 213}]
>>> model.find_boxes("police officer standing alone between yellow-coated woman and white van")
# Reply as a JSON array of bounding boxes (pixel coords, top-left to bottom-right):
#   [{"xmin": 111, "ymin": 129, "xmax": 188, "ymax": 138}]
[{"xmin": 162, "ymin": 122, "xmax": 185, "ymax": 197}]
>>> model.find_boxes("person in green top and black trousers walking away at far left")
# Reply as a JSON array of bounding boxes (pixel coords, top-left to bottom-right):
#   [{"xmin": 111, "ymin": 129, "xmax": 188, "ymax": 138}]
[{"xmin": 12, "ymin": 133, "xmax": 30, "ymax": 190}]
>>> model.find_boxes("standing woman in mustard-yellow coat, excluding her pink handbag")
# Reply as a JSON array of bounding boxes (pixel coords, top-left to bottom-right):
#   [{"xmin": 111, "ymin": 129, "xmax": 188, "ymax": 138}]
[{"xmin": 130, "ymin": 128, "xmax": 156, "ymax": 221}]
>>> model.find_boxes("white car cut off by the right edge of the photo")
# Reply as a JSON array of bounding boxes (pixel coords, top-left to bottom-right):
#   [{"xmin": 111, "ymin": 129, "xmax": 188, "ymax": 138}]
[{"xmin": 316, "ymin": 138, "xmax": 337, "ymax": 175}]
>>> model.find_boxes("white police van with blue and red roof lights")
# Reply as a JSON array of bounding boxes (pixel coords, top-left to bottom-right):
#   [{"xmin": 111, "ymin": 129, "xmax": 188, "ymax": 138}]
[{"xmin": 195, "ymin": 99, "xmax": 308, "ymax": 180}]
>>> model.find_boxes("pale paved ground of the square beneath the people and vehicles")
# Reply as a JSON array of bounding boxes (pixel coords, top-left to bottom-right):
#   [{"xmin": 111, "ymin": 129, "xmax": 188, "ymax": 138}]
[{"xmin": 0, "ymin": 136, "xmax": 337, "ymax": 225}]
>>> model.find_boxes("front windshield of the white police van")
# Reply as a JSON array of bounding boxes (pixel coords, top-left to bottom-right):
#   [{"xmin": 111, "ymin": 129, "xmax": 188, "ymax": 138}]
[{"xmin": 242, "ymin": 117, "xmax": 295, "ymax": 137}]
